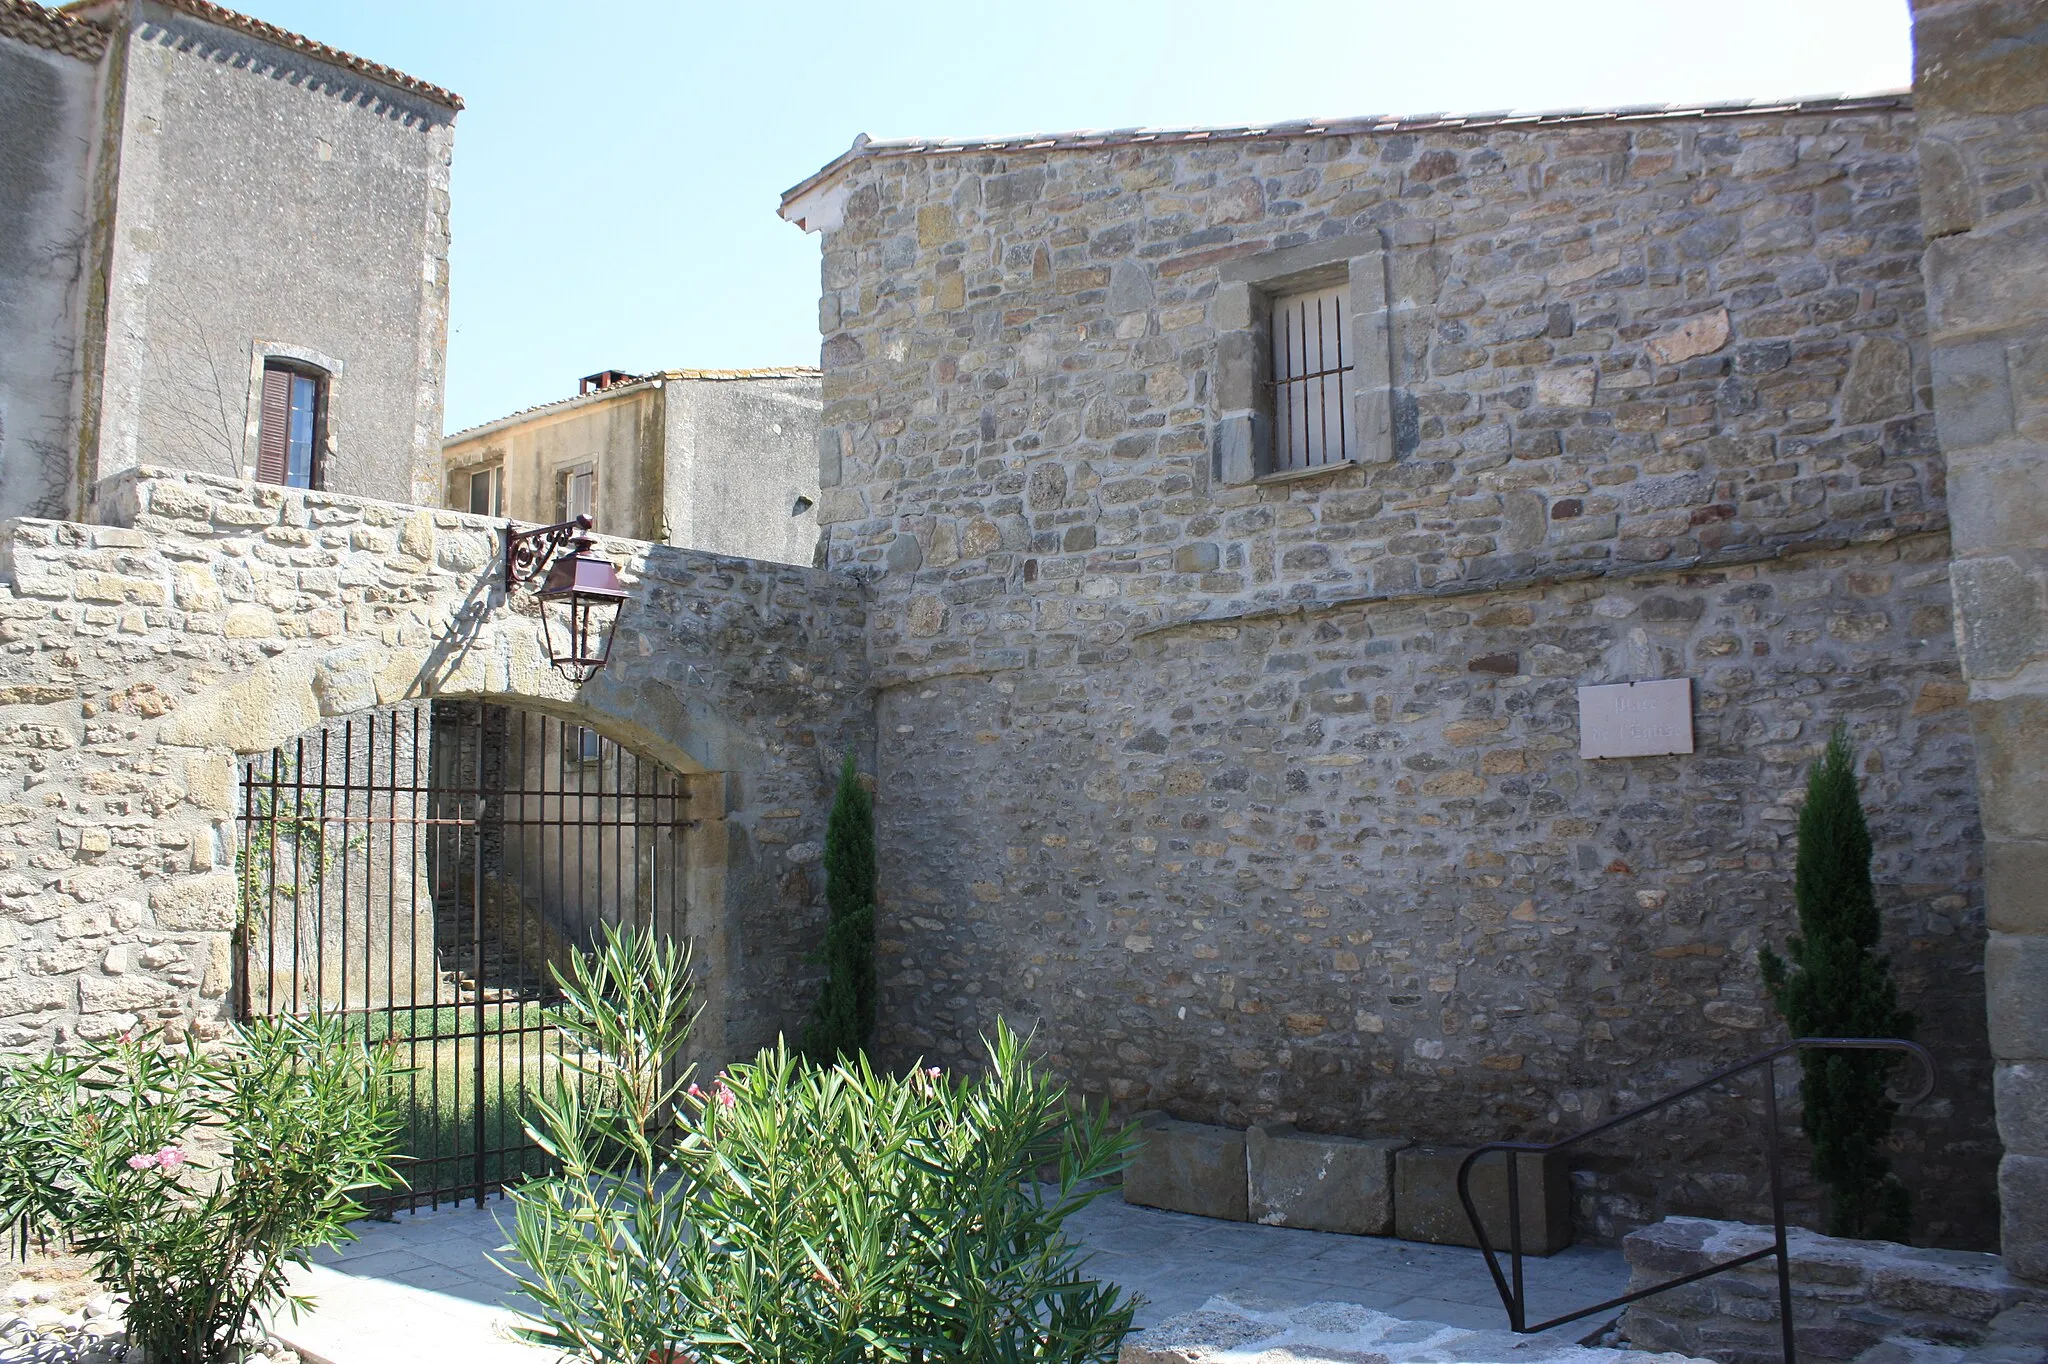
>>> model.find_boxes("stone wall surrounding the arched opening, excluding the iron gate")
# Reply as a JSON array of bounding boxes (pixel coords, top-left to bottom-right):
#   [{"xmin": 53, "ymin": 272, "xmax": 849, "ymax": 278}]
[{"xmin": 0, "ymin": 469, "xmax": 870, "ymax": 1061}]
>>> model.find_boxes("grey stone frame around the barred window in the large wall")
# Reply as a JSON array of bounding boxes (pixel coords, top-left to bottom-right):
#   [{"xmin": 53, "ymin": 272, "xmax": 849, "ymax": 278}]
[{"xmin": 1210, "ymin": 233, "xmax": 1395, "ymax": 485}]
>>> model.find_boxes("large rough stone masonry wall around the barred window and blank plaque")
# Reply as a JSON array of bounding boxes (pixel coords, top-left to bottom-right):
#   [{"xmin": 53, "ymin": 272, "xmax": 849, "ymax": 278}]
[{"xmin": 784, "ymin": 98, "xmax": 1997, "ymax": 1247}]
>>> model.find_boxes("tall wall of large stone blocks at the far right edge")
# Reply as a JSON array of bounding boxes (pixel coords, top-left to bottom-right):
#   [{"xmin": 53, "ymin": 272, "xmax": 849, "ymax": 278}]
[{"xmin": 1913, "ymin": 0, "xmax": 2048, "ymax": 1278}]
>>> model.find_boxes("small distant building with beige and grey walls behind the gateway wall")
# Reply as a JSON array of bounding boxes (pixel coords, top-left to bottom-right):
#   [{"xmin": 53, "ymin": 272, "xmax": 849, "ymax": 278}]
[{"xmin": 440, "ymin": 367, "xmax": 819, "ymax": 563}]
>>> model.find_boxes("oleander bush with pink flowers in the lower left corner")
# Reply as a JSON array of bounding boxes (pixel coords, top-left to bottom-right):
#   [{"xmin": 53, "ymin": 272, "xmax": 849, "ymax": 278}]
[{"xmin": 0, "ymin": 1018, "xmax": 401, "ymax": 1364}]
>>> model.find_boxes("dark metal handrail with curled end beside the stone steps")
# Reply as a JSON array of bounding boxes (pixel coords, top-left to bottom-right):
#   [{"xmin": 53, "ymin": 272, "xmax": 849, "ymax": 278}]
[{"xmin": 1458, "ymin": 1036, "xmax": 1935, "ymax": 1364}]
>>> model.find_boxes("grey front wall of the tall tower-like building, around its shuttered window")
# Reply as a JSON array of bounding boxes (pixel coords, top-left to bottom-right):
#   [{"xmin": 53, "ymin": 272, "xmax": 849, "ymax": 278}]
[{"xmin": 72, "ymin": 2, "xmax": 455, "ymax": 508}]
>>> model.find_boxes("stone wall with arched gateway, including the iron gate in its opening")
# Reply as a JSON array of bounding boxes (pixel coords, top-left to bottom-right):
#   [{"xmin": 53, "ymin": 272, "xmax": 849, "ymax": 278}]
[{"xmin": 0, "ymin": 469, "xmax": 872, "ymax": 1198}]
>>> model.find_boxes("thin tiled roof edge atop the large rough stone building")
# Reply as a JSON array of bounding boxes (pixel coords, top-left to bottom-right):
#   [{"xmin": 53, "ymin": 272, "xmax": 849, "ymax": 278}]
[{"xmin": 782, "ymin": 90, "xmax": 1913, "ymax": 207}]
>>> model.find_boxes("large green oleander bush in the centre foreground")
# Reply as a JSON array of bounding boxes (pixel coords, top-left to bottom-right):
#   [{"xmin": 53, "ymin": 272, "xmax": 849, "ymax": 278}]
[{"xmin": 497, "ymin": 917, "xmax": 1133, "ymax": 1364}]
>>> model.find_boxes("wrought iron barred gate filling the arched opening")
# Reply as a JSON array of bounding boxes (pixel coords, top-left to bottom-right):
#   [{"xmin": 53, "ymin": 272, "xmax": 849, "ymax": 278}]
[{"xmin": 238, "ymin": 700, "xmax": 690, "ymax": 1206}]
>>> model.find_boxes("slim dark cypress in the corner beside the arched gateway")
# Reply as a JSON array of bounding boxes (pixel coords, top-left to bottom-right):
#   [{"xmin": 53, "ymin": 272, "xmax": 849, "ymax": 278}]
[{"xmin": 803, "ymin": 752, "xmax": 874, "ymax": 1065}]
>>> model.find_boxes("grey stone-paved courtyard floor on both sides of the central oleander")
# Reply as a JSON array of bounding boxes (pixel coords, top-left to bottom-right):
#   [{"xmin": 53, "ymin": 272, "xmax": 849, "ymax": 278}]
[{"xmin": 279, "ymin": 1190, "xmax": 1628, "ymax": 1364}]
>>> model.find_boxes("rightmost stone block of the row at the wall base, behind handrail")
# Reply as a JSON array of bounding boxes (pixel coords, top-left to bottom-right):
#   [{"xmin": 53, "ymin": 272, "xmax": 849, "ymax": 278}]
[{"xmin": 1395, "ymin": 1147, "xmax": 1571, "ymax": 1255}]
